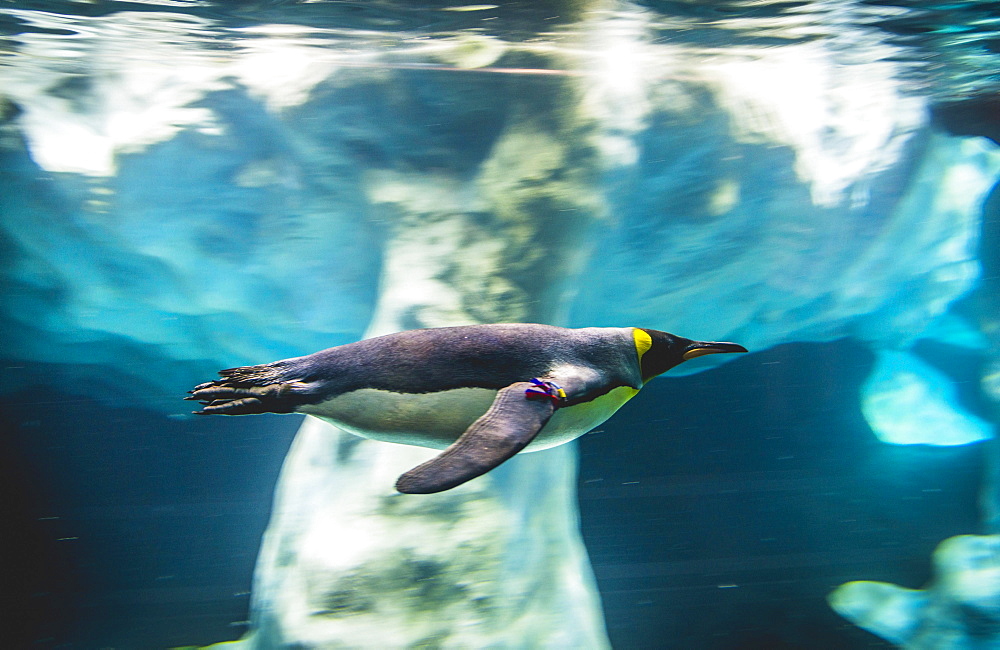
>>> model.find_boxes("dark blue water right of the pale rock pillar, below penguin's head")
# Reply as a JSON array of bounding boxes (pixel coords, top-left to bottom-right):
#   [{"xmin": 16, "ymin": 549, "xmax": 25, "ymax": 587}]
[{"xmin": 580, "ymin": 342, "xmax": 983, "ymax": 649}]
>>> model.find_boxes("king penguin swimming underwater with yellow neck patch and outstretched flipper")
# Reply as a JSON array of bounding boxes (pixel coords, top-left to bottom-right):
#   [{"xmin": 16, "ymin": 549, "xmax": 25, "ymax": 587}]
[{"xmin": 186, "ymin": 323, "xmax": 747, "ymax": 494}]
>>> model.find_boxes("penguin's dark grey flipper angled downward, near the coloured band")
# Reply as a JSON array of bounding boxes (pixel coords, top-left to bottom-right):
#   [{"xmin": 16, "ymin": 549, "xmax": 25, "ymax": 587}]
[{"xmin": 396, "ymin": 382, "xmax": 556, "ymax": 494}]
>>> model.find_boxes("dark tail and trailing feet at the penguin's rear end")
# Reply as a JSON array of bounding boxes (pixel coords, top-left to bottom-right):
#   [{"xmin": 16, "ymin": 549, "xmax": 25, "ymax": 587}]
[{"xmin": 184, "ymin": 361, "xmax": 307, "ymax": 415}]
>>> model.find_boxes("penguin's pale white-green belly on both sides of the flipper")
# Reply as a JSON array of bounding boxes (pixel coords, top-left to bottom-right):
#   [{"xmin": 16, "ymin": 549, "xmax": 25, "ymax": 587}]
[{"xmin": 299, "ymin": 386, "xmax": 639, "ymax": 451}]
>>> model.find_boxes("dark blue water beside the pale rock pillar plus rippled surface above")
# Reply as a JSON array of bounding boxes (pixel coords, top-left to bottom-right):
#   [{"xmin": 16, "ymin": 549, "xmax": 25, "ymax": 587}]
[{"xmin": 0, "ymin": 0, "xmax": 1000, "ymax": 649}]
